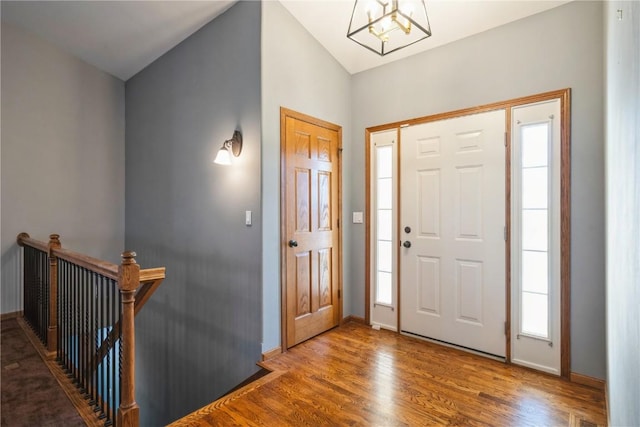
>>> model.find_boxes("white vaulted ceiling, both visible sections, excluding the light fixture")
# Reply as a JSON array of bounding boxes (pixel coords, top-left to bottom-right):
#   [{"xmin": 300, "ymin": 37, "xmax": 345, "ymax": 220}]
[{"xmin": 2, "ymin": 0, "xmax": 567, "ymax": 80}]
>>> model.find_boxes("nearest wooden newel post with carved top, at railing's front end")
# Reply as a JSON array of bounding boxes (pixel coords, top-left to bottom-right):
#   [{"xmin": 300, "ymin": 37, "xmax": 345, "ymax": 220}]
[{"xmin": 117, "ymin": 251, "xmax": 140, "ymax": 426}]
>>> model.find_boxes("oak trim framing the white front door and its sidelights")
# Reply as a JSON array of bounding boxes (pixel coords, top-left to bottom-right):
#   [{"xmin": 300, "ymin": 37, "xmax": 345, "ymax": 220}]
[{"xmin": 364, "ymin": 88, "xmax": 571, "ymax": 378}]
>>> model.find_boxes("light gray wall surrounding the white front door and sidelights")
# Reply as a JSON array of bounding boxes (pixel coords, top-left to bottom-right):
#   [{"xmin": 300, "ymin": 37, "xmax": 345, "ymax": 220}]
[{"xmin": 350, "ymin": 2, "xmax": 605, "ymax": 378}]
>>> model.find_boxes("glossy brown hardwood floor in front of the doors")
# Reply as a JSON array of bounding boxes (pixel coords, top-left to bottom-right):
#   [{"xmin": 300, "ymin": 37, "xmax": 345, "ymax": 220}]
[{"xmin": 172, "ymin": 322, "xmax": 606, "ymax": 426}]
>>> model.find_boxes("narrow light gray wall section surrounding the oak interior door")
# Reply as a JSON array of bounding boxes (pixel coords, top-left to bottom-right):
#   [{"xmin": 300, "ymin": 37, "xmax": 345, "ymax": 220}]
[{"xmin": 262, "ymin": 1, "xmax": 353, "ymax": 351}]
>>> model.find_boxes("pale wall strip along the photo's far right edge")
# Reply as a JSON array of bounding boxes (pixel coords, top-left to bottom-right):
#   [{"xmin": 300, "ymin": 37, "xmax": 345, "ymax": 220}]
[{"xmin": 604, "ymin": 1, "xmax": 640, "ymax": 426}]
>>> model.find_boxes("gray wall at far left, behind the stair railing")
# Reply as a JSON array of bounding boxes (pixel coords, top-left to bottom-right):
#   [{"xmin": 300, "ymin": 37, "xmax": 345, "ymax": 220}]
[{"xmin": 0, "ymin": 22, "xmax": 125, "ymax": 313}]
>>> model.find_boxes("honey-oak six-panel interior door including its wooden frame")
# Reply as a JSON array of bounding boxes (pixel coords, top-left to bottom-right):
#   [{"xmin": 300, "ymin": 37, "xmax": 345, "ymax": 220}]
[{"xmin": 281, "ymin": 108, "xmax": 342, "ymax": 348}]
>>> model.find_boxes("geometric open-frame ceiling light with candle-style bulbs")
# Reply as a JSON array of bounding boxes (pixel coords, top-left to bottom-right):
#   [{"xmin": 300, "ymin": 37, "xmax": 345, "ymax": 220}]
[{"xmin": 347, "ymin": 0, "xmax": 431, "ymax": 56}]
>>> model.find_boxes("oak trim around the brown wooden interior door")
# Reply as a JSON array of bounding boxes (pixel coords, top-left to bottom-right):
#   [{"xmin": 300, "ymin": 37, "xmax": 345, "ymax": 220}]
[{"xmin": 280, "ymin": 107, "xmax": 344, "ymax": 352}]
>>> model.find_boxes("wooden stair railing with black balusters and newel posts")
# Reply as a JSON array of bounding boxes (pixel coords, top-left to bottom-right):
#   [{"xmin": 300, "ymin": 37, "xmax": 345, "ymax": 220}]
[{"xmin": 17, "ymin": 233, "xmax": 165, "ymax": 426}]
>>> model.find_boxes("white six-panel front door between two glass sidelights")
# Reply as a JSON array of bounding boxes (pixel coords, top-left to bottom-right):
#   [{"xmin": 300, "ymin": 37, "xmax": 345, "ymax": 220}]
[{"xmin": 399, "ymin": 110, "xmax": 506, "ymax": 357}]
